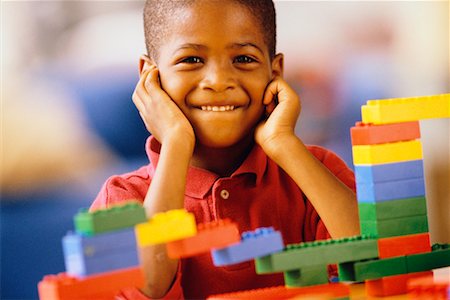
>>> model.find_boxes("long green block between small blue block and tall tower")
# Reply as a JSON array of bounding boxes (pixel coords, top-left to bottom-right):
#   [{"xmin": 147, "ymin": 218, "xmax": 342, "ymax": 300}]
[{"xmin": 255, "ymin": 236, "xmax": 378, "ymax": 274}]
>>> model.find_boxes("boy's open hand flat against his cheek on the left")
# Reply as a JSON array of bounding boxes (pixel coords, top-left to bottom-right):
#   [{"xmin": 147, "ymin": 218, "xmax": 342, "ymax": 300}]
[{"xmin": 133, "ymin": 66, "xmax": 195, "ymax": 145}]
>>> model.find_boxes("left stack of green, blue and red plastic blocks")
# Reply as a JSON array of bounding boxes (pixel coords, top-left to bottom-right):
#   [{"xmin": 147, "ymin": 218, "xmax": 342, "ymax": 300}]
[{"xmin": 38, "ymin": 202, "xmax": 146, "ymax": 300}]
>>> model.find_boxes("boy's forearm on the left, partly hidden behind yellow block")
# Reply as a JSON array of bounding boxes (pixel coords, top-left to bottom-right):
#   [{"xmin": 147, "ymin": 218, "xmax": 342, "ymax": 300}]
[{"xmin": 140, "ymin": 139, "xmax": 194, "ymax": 298}]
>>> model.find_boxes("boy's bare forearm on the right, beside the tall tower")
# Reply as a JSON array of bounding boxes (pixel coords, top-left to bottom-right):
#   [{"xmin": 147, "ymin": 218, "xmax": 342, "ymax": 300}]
[{"xmin": 269, "ymin": 135, "xmax": 359, "ymax": 238}]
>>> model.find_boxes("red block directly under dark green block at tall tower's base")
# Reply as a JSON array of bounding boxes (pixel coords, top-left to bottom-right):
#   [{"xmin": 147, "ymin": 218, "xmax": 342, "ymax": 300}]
[{"xmin": 365, "ymin": 271, "xmax": 433, "ymax": 297}]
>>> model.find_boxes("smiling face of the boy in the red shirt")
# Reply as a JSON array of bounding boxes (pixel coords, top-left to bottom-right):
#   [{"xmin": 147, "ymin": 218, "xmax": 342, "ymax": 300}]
[{"xmin": 147, "ymin": 0, "xmax": 282, "ymax": 148}]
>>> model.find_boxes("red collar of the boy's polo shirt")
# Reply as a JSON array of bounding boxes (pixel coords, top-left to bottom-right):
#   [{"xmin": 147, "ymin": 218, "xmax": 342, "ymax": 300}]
[{"xmin": 145, "ymin": 136, "xmax": 268, "ymax": 199}]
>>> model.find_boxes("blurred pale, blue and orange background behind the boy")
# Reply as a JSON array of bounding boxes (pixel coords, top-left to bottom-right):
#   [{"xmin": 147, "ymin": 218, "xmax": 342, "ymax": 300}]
[{"xmin": 0, "ymin": 0, "xmax": 450, "ymax": 299}]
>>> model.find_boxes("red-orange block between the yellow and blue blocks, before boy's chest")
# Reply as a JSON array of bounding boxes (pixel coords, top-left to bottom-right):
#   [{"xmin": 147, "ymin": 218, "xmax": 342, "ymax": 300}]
[{"xmin": 166, "ymin": 219, "xmax": 241, "ymax": 258}]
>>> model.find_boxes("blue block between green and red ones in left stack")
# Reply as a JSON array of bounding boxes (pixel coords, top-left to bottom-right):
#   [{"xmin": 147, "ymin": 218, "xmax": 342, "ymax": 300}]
[{"xmin": 62, "ymin": 228, "xmax": 139, "ymax": 277}]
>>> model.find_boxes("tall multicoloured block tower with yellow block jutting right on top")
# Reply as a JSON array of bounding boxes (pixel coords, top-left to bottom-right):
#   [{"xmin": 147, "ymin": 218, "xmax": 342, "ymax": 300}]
[{"xmin": 348, "ymin": 94, "xmax": 450, "ymax": 296}]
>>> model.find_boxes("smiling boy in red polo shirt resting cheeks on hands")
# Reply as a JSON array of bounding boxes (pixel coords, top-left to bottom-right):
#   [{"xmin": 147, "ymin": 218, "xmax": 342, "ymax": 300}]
[{"xmin": 92, "ymin": 0, "xmax": 359, "ymax": 299}]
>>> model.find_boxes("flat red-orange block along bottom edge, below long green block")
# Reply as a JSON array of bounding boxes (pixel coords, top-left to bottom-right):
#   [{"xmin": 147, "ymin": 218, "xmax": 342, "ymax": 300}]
[{"xmin": 208, "ymin": 283, "xmax": 350, "ymax": 300}]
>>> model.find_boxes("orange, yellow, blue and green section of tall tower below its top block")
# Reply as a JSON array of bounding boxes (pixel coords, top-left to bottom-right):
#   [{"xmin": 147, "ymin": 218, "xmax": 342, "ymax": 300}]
[{"xmin": 351, "ymin": 121, "xmax": 429, "ymax": 239}]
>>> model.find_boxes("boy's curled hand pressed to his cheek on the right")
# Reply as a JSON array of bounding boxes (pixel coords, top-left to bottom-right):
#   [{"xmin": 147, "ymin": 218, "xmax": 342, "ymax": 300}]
[{"xmin": 255, "ymin": 77, "xmax": 301, "ymax": 158}]
